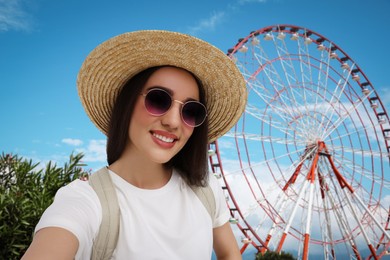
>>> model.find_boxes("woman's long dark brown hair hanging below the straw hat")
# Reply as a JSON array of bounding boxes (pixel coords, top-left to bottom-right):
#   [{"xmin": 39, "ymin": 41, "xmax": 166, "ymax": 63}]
[{"xmin": 107, "ymin": 66, "xmax": 208, "ymax": 186}]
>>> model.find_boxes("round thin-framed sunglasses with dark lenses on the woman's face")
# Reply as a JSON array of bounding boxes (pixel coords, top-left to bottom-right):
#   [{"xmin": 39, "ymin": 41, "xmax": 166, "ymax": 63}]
[{"xmin": 141, "ymin": 88, "xmax": 207, "ymax": 127}]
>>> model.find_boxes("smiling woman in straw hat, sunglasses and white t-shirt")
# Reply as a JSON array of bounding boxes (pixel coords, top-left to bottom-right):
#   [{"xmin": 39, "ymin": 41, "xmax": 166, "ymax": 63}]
[{"xmin": 23, "ymin": 31, "xmax": 246, "ymax": 259}]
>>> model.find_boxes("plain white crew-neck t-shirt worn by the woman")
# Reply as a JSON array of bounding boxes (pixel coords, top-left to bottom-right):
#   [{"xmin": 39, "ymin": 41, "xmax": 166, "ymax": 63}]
[{"xmin": 35, "ymin": 171, "xmax": 229, "ymax": 260}]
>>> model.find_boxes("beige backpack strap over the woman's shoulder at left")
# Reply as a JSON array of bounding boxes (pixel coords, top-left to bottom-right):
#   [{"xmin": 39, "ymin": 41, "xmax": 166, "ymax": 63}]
[{"xmin": 89, "ymin": 167, "xmax": 120, "ymax": 260}]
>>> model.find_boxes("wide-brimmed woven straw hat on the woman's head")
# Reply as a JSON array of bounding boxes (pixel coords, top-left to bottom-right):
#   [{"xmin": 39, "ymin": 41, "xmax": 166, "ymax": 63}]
[{"xmin": 77, "ymin": 30, "xmax": 247, "ymax": 142}]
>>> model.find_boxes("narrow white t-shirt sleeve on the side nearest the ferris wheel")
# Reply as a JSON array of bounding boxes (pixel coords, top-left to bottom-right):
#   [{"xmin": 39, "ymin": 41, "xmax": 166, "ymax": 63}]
[{"xmin": 209, "ymin": 175, "xmax": 230, "ymax": 228}]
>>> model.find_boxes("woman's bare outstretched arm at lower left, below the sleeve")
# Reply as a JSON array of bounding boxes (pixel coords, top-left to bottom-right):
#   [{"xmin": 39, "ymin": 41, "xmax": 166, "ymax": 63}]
[{"xmin": 22, "ymin": 227, "xmax": 79, "ymax": 260}]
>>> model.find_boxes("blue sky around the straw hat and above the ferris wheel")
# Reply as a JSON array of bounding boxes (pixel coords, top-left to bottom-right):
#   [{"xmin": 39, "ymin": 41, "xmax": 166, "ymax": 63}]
[{"xmin": 0, "ymin": 0, "xmax": 390, "ymax": 258}]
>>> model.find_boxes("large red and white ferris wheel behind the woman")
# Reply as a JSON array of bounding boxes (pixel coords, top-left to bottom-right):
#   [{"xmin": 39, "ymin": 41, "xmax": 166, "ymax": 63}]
[{"xmin": 209, "ymin": 25, "xmax": 390, "ymax": 259}]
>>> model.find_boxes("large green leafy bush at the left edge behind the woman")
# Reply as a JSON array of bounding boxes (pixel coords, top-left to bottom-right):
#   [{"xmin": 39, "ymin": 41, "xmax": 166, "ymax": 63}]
[{"xmin": 0, "ymin": 153, "xmax": 87, "ymax": 259}]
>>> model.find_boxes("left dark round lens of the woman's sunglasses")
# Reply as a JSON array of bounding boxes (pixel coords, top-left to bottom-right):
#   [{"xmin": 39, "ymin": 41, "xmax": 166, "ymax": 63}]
[{"xmin": 145, "ymin": 89, "xmax": 172, "ymax": 116}]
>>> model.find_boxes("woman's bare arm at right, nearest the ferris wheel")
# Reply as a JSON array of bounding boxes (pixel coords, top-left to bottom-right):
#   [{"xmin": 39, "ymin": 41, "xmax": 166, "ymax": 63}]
[{"xmin": 213, "ymin": 222, "xmax": 242, "ymax": 260}]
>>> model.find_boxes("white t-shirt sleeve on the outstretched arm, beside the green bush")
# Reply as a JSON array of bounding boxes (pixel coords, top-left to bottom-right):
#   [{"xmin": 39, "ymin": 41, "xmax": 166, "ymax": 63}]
[{"xmin": 35, "ymin": 180, "xmax": 102, "ymax": 259}]
